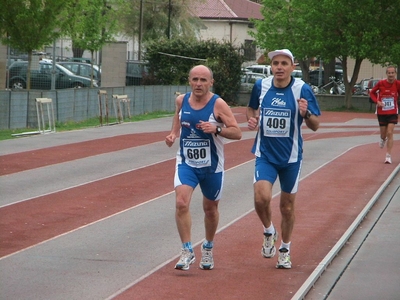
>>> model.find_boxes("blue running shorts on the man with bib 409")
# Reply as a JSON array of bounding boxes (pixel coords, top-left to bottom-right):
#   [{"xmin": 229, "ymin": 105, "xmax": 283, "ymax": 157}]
[{"xmin": 254, "ymin": 157, "xmax": 302, "ymax": 194}]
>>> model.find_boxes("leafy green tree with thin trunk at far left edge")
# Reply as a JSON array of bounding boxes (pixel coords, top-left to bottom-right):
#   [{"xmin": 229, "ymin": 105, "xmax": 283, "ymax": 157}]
[{"xmin": 0, "ymin": 0, "xmax": 72, "ymax": 89}]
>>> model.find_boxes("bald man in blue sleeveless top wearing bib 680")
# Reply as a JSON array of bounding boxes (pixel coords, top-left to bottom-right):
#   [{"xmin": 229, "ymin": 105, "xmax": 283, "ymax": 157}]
[{"xmin": 165, "ymin": 65, "xmax": 242, "ymax": 270}]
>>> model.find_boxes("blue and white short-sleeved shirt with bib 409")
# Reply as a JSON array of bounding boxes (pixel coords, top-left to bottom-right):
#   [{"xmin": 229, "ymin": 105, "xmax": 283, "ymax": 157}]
[{"xmin": 248, "ymin": 77, "xmax": 321, "ymax": 164}]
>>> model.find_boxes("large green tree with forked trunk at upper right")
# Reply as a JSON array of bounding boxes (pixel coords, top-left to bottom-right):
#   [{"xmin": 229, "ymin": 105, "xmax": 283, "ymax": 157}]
[{"xmin": 255, "ymin": 0, "xmax": 400, "ymax": 108}]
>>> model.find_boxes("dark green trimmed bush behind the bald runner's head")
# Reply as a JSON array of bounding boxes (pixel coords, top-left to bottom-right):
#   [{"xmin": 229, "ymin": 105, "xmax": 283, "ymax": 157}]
[{"xmin": 145, "ymin": 38, "xmax": 243, "ymax": 104}]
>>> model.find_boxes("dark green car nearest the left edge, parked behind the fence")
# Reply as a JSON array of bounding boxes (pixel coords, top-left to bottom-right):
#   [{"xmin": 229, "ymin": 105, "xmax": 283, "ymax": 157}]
[{"xmin": 8, "ymin": 61, "xmax": 98, "ymax": 90}]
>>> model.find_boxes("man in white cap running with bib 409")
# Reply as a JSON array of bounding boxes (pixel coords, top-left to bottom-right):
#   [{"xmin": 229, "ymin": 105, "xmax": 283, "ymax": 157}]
[{"xmin": 247, "ymin": 49, "xmax": 320, "ymax": 269}]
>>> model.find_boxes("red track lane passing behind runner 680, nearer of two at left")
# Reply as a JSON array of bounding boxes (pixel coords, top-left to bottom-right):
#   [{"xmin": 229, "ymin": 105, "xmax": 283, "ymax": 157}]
[{"xmin": 0, "ymin": 140, "xmax": 253, "ymax": 257}]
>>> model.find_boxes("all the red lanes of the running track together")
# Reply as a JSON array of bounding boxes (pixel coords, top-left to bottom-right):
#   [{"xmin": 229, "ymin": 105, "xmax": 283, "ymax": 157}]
[{"xmin": 0, "ymin": 108, "xmax": 400, "ymax": 299}]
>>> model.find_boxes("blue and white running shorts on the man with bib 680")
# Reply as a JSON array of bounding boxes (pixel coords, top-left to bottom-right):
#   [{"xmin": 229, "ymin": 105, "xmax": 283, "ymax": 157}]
[{"xmin": 174, "ymin": 164, "xmax": 224, "ymax": 201}]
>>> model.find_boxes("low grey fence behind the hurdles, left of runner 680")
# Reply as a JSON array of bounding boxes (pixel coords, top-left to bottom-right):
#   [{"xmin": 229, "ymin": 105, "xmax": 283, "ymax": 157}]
[{"xmin": 0, "ymin": 86, "xmax": 190, "ymax": 129}]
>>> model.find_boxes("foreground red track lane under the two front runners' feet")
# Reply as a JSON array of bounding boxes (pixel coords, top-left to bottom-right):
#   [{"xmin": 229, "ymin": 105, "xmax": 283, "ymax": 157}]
[{"xmin": 109, "ymin": 141, "xmax": 400, "ymax": 300}]
